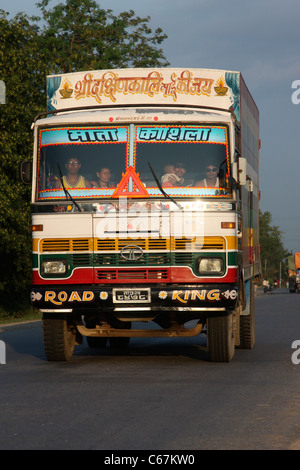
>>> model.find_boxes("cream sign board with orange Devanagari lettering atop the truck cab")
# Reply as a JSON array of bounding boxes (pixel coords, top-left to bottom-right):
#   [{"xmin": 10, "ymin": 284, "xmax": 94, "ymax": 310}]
[{"xmin": 47, "ymin": 68, "xmax": 241, "ymax": 121}]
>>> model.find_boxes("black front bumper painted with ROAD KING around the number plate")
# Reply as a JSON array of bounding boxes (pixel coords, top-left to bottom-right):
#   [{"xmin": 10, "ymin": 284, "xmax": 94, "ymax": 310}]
[{"xmin": 31, "ymin": 284, "xmax": 238, "ymax": 312}]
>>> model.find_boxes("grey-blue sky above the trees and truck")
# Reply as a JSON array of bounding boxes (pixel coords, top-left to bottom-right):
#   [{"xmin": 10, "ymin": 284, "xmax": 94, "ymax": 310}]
[{"xmin": 0, "ymin": 0, "xmax": 300, "ymax": 253}]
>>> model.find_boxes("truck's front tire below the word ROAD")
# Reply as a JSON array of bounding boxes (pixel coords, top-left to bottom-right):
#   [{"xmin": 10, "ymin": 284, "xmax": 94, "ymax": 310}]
[{"xmin": 43, "ymin": 317, "xmax": 76, "ymax": 361}]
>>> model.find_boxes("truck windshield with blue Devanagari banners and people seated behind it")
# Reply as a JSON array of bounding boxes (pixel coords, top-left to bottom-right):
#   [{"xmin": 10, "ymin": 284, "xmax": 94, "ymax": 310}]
[{"xmin": 36, "ymin": 125, "xmax": 230, "ymax": 201}]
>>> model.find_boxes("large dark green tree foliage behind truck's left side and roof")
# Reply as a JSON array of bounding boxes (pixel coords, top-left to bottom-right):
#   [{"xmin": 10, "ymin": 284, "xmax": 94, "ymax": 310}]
[{"xmin": 0, "ymin": 0, "xmax": 168, "ymax": 308}]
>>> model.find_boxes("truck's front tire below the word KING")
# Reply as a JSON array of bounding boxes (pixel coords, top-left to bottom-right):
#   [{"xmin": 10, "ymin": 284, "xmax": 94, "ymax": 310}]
[{"xmin": 207, "ymin": 313, "xmax": 235, "ymax": 362}]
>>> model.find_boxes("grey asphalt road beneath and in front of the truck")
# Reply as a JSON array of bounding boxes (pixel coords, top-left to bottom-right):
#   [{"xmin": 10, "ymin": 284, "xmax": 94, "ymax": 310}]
[{"xmin": 0, "ymin": 289, "xmax": 300, "ymax": 451}]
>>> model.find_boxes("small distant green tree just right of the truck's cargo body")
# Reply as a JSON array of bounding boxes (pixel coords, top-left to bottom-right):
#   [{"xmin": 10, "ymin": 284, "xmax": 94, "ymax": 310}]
[{"xmin": 259, "ymin": 211, "xmax": 289, "ymax": 279}]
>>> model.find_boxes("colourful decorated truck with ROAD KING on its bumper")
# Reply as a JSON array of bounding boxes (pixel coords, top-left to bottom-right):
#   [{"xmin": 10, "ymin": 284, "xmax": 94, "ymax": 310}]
[{"xmin": 20, "ymin": 68, "xmax": 260, "ymax": 362}]
